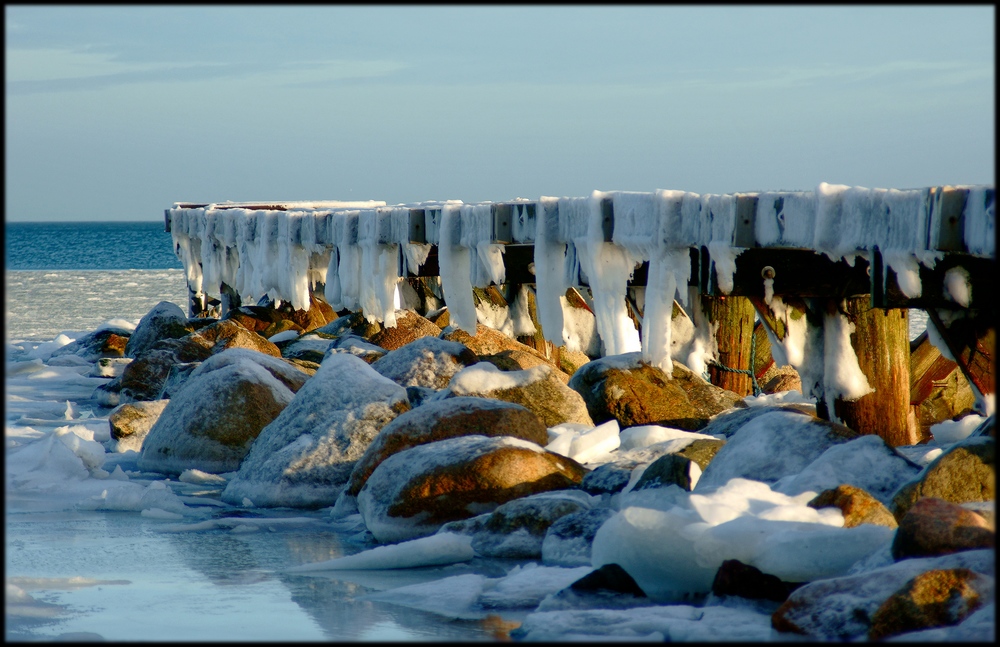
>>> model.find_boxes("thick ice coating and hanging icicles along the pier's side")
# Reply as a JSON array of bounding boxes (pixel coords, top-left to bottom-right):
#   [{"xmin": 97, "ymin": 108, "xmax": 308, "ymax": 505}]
[{"xmin": 166, "ymin": 183, "xmax": 995, "ymax": 371}]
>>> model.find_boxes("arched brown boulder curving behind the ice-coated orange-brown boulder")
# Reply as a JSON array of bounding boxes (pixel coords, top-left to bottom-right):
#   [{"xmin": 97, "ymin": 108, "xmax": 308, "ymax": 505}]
[{"xmin": 346, "ymin": 394, "xmax": 548, "ymax": 496}]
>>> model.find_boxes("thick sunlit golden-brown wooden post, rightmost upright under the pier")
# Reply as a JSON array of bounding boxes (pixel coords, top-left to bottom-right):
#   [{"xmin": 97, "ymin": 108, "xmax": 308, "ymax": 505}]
[{"xmin": 833, "ymin": 295, "xmax": 920, "ymax": 447}]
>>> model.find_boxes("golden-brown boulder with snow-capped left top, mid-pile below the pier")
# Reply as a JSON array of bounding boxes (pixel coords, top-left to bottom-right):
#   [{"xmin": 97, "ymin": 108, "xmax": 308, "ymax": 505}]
[{"xmin": 448, "ymin": 365, "xmax": 594, "ymax": 427}]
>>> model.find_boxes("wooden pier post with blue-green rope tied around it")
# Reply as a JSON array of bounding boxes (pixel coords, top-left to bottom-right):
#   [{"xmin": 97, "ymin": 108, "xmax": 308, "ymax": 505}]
[{"xmin": 701, "ymin": 296, "xmax": 754, "ymax": 396}]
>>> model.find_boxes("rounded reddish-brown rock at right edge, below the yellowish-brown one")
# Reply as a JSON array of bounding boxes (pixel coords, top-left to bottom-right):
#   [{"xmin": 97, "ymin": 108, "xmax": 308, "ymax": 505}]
[{"xmin": 892, "ymin": 497, "xmax": 995, "ymax": 560}]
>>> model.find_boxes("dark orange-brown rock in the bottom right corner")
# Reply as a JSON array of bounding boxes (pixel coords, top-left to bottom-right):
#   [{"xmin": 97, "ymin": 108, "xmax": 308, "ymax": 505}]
[{"xmin": 868, "ymin": 568, "xmax": 993, "ymax": 641}]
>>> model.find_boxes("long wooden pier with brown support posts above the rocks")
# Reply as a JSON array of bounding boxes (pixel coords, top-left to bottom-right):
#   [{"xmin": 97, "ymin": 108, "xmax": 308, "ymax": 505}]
[{"xmin": 165, "ymin": 185, "xmax": 996, "ymax": 445}]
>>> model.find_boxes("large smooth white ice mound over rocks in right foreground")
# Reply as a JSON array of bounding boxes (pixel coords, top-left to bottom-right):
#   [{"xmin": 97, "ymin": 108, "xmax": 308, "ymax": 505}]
[{"xmin": 592, "ymin": 479, "xmax": 892, "ymax": 601}]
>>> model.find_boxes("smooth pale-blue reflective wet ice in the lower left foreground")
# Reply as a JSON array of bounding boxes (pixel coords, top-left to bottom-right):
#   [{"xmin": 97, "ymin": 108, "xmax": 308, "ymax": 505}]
[{"xmin": 6, "ymin": 511, "xmax": 520, "ymax": 641}]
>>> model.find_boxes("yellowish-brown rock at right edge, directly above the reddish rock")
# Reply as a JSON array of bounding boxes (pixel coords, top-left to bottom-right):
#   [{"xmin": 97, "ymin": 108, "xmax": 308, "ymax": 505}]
[{"xmin": 892, "ymin": 436, "xmax": 996, "ymax": 521}]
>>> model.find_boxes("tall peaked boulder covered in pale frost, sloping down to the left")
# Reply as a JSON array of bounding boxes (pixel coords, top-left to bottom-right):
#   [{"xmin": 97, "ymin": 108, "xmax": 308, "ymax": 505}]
[{"xmin": 222, "ymin": 353, "xmax": 410, "ymax": 507}]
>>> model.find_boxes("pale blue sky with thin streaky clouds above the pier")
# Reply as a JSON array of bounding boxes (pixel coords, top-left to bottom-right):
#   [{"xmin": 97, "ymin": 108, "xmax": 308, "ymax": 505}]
[{"xmin": 4, "ymin": 5, "xmax": 996, "ymax": 222}]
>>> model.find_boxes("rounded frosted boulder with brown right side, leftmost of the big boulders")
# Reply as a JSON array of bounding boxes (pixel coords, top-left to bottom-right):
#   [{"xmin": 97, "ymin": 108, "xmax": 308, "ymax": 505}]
[{"xmin": 138, "ymin": 359, "xmax": 294, "ymax": 474}]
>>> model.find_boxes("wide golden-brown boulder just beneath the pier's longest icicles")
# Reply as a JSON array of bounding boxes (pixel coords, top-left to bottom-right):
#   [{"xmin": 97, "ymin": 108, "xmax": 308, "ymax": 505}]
[{"xmin": 569, "ymin": 353, "xmax": 746, "ymax": 431}]
